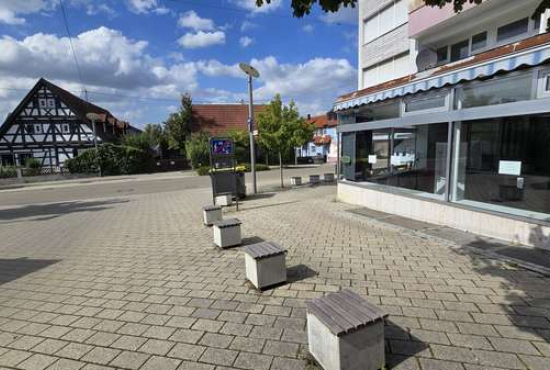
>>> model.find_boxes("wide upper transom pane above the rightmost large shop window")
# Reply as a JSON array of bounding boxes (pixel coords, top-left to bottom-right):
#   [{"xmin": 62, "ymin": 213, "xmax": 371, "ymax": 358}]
[{"xmin": 455, "ymin": 73, "xmax": 533, "ymax": 109}]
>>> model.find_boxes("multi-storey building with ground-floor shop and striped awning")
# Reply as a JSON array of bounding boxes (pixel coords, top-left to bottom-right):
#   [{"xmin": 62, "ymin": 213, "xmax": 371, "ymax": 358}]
[{"xmin": 334, "ymin": 0, "xmax": 550, "ymax": 248}]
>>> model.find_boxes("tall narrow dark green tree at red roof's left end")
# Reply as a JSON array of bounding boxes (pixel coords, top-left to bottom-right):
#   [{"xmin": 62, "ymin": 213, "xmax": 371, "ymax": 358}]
[{"xmin": 164, "ymin": 94, "xmax": 194, "ymax": 154}]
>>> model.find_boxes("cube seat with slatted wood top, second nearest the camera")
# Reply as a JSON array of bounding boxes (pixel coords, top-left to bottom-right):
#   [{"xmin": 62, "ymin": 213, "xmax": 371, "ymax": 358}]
[{"xmin": 244, "ymin": 242, "xmax": 286, "ymax": 289}]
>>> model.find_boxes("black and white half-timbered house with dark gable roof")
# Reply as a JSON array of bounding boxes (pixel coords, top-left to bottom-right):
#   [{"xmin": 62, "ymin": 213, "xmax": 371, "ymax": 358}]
[{"xmin": 0, "ymin": 79, "xmax": 133, "ymax": 169}]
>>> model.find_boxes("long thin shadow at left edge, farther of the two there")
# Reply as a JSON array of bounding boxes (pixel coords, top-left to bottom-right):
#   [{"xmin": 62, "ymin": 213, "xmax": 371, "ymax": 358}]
[{"xmin": 0, "ymin": 200, "xmax": 129, "ymax": 224}]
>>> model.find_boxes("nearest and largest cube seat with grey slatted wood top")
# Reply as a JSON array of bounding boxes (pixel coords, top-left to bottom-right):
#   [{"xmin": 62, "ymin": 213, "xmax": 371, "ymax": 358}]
[{"xmin": 306, "ymin": 290, "xmax": 388, "ymax": 370}]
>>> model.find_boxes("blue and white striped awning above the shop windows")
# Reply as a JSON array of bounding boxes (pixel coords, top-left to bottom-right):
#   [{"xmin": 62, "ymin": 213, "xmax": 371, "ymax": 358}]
[{"xmin": 334, "ymin": 44, "xmax": 550, "ymax": 111}]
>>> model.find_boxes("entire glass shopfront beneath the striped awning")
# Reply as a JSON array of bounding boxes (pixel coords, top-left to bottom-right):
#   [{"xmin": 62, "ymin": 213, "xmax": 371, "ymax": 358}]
[{"xmin": 341, "ymin": 68, "xmax": 550, "ymax": 221}]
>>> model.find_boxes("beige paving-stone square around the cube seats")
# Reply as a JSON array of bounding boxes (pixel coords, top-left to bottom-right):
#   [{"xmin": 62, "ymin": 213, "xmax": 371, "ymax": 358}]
[{"xmin": 0, "ymin": 186, "xmax": 550, "ymax": 370}]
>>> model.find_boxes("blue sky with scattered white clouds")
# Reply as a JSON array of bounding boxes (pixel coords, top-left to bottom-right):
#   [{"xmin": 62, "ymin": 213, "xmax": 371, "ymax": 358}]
[{"xmin": 0, "ymin": 0, "xmax": 357, "ymax": 127}]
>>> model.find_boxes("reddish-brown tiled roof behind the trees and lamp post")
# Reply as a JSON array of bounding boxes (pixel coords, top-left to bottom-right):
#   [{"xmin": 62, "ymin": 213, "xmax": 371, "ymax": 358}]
[{"xmin": 193, "ymin": 104, "xmax": 266, "ymax": 135}]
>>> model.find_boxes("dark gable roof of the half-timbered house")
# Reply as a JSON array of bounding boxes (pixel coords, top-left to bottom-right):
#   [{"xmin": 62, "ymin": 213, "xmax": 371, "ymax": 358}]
[{"xmin": 0, "ymin": 78, "xmax": 136, "ymax": 136}]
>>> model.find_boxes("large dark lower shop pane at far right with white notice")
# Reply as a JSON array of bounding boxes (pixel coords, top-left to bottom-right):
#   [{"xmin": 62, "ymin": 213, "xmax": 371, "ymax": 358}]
[{"xmin": 452, "ymin": 114, "xmax": 550, "ymax": 220}]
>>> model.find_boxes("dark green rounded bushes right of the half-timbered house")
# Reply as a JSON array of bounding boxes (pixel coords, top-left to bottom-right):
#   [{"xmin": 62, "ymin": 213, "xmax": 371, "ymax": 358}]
[{"xmin": 65, "ymin": 144, "xmax": 152, "ymax": 176}]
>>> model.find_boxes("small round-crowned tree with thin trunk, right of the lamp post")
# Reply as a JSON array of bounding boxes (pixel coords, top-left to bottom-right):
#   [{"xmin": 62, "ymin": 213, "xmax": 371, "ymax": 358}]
[{"xmin": 258, "ymin": 94, "xmax": 314, "ymax": 188}]
